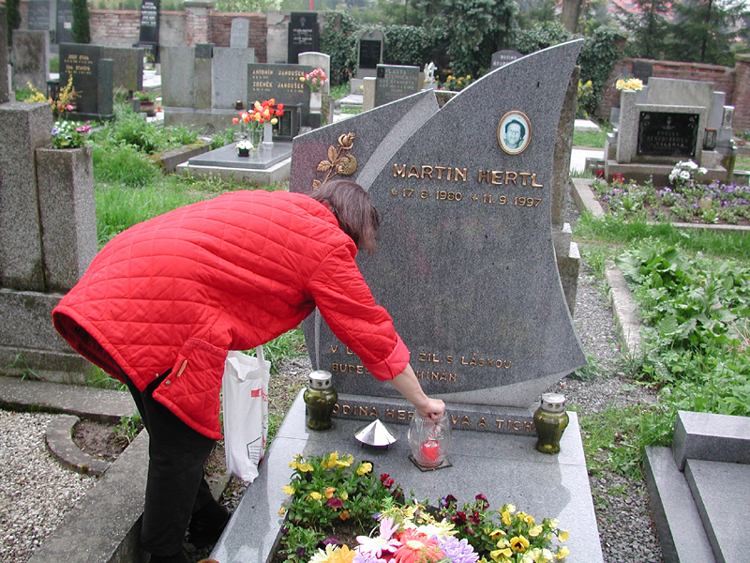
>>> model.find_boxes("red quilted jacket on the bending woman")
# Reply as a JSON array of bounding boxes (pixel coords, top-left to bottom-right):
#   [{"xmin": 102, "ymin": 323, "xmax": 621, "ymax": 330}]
[{"xmin": 52, "ymin": 190, "xmax": 409, "ymax": 439}]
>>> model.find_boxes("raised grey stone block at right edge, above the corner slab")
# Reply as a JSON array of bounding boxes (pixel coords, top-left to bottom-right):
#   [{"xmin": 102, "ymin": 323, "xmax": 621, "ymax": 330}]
[{"xmin": 672, "ymin": 411, "xmax": 750, "ymax": 471}]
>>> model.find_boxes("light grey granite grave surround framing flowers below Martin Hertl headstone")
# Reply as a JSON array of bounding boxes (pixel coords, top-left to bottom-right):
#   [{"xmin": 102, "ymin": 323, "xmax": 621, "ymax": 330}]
[{"xmin": 211, "ymin": 393, "xmax": 603, "ymax": 563}]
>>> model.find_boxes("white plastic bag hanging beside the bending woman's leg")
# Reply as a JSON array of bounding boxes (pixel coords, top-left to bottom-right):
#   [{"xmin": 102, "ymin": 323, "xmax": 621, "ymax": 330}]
[{"xmin": 222, "ymin": 346, "xmax": 271, "ymax": 483}]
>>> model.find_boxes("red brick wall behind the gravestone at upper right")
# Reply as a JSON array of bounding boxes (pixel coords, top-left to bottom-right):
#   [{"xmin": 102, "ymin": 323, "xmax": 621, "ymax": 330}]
[{"xmin": 596, "ymin": 56, "xmax": 750, "ymax": 131}]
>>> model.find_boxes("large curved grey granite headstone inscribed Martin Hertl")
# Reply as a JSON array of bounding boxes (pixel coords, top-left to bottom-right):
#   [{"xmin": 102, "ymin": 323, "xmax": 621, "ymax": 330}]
[{"xmin": 290, "ymin": 41, "xmax": 586, "ymax": 433}]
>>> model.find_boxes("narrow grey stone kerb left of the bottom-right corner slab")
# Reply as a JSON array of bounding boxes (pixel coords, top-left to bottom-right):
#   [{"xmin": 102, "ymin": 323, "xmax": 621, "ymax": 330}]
[{"xmin": 643, "ymin": 447, "xmax": 716, "ymax": 563}]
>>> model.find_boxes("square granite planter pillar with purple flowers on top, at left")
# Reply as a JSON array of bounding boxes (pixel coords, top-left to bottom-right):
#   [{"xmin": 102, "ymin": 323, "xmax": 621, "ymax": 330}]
[{"xmin": 35, "ymin": 147, "xmax": 97, "ymax": 292}]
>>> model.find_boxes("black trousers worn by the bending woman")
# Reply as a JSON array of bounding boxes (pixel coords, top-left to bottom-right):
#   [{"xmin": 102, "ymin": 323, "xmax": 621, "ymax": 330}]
[{"xmin": 122, "ymin": 371, "xmax": 218, "ymax": 556}]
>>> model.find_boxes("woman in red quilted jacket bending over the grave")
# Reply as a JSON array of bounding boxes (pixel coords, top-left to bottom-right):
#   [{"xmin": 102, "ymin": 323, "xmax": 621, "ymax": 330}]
[{"xmin": 52, "ymin": 180, "xmax": 445, "ymax": 563}]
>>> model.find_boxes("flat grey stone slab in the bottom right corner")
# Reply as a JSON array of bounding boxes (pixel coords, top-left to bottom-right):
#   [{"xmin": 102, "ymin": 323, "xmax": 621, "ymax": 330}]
[{"xmin": 685, "ymin": 459, "xmax": 750, "ymax": 563}]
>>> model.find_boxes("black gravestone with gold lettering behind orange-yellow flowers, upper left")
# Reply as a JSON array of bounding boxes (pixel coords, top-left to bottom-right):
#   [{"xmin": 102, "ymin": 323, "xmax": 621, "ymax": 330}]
[{"xmin": 60, "ymin": 43, "xmax": 114, "ymax": 121}]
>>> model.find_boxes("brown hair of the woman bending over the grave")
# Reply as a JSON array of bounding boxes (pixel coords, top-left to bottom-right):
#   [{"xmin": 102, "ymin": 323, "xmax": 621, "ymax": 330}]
[{"xmin": 312, "ymin": 180, "xmax": 380, "ymax": 254}]
